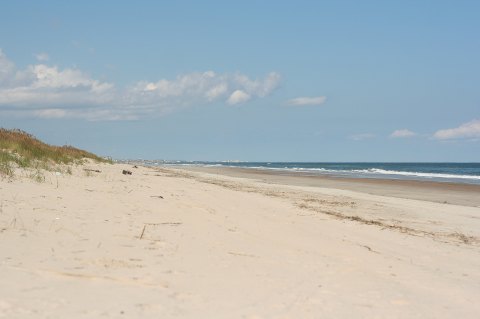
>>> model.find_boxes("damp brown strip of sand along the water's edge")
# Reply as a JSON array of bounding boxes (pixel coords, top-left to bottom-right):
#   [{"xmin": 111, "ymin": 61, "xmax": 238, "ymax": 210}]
[{"xmin": 173, "ymin": 165, "xmax": 480, "ymax": 207}]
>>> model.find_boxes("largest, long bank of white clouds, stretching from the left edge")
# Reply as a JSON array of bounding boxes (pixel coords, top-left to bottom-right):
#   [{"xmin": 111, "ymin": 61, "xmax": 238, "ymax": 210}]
[{"xmin": 0, "ymin": 49, "xmax": 280, "ymax": 120}]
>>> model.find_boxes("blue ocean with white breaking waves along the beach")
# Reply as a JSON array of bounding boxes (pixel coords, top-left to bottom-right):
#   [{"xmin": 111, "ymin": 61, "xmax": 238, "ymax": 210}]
[{"xmin": 136, "ymin": 160, "xmax": 480, "ymax": 185}]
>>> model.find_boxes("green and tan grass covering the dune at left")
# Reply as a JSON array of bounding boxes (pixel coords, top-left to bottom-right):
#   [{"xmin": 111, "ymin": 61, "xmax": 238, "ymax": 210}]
[{"xmin": 0, "ymin": 128, "xmax": 109, "ymax": 176}]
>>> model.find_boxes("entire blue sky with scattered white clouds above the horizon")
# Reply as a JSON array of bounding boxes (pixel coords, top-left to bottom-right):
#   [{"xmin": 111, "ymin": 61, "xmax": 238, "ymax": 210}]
[{"xmin": 0, "ymin": 0, "xmax": 480, "ymax": 162}]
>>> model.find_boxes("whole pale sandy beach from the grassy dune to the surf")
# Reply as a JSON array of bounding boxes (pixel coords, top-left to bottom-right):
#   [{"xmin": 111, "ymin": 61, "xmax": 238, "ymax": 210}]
[{"xmin": 0, "ymin": 164, "xmax": 480, "ymax": 319}]
